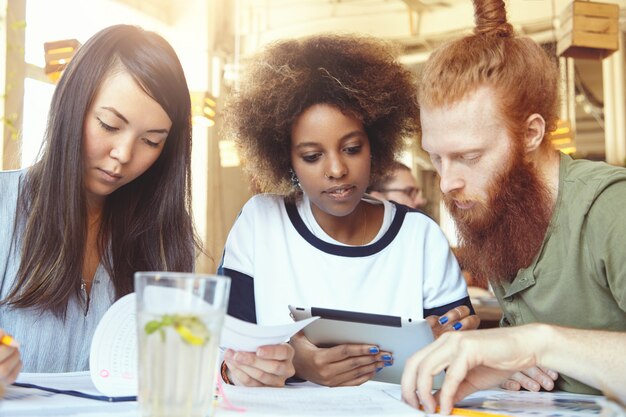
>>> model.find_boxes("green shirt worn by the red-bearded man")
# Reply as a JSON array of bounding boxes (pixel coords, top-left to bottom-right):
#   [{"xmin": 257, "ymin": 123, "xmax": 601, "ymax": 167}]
[{"xmin": 492, "ymin": 154, "xmax": 626, "ymax": 394}]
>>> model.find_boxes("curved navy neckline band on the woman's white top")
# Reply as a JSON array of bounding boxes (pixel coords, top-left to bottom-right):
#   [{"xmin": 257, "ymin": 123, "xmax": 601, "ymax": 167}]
[{"xmin": 285, "ymin": 201, "xmax": 412, "ymax": 258}]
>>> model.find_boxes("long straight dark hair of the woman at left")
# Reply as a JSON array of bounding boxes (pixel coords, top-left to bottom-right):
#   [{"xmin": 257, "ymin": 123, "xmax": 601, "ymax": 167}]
[{"xmin": 2, "ymin": 25, "xmax": 200, "ymax": 317}]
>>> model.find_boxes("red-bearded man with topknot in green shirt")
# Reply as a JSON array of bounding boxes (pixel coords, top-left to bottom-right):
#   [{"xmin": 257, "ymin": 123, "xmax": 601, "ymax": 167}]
[{"xmin": 403, "ymin": 0, "xmax": 626, "ymax": 410}]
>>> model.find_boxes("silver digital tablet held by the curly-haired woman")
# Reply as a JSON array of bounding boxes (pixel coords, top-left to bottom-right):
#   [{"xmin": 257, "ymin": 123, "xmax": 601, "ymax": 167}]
[{"xmin": 289, "ymin": 305, "xmax": 443, "ymax": 388}]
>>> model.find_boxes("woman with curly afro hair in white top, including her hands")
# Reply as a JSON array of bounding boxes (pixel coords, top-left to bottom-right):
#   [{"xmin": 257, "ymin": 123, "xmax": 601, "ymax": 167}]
[{"xmin": 219, "ymin": 35, "xmax": 479, "ymax": 386}]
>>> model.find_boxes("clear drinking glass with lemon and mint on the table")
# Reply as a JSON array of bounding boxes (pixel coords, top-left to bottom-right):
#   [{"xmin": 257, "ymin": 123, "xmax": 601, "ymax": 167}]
[{"xmin": 135, "ymin": 272, "xmax": 230, "ymax": 417}]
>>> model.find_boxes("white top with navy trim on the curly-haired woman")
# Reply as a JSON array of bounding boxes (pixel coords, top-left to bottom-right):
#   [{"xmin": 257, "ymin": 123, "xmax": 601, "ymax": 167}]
[{"xmin": 219, "ymin": 194, "xmax": 471, "ymax": 325}]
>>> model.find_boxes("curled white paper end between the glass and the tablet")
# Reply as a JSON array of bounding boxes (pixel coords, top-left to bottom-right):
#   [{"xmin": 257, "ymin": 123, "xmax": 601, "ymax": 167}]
[{"xmin": 220, "ymin": 315, "xmax": 319, "ymax": 352}]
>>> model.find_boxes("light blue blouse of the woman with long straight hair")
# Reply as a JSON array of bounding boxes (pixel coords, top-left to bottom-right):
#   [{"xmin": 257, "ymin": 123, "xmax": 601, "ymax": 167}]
[{"xmin": 0, "ymin": 169, "xmax": 115, "ymax": 372}]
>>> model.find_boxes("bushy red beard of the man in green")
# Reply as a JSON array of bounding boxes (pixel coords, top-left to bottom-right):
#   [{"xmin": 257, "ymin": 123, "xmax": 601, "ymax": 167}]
[{"xmin": 443, "ymin": 149, "xmax": 552, "ymax": 284}]
